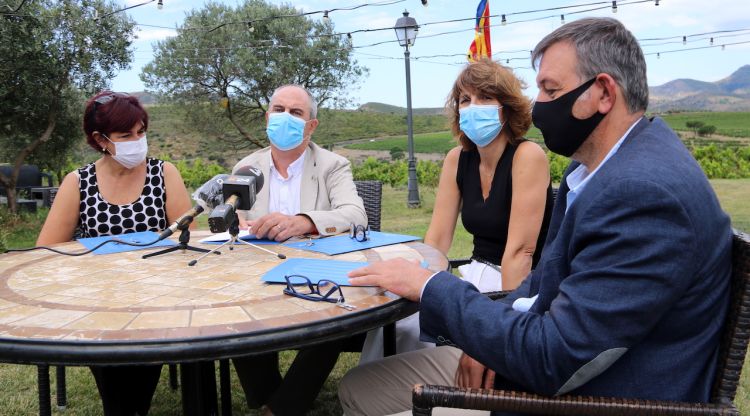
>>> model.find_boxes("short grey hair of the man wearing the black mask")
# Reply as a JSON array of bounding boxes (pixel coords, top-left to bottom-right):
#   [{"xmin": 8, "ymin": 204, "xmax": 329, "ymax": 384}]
[{"xmin": 531, "ymin": 17, "xmax": 648, "ymax": 114}]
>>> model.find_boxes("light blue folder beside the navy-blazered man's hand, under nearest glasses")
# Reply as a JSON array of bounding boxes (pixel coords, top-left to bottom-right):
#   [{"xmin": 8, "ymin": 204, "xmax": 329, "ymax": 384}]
[{"xmin": 262, "ymin": 256, "xmax": 374, "ymax": 286}]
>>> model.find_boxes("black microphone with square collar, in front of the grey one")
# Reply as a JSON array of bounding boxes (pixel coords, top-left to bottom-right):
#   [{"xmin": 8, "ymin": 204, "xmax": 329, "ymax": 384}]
[{"xmin": 208, "ymin": 166, "xmax": 263, "ymax": 233}]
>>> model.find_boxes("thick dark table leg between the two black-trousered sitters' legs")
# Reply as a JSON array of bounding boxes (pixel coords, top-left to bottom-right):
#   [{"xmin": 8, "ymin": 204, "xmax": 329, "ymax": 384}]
[{"xmin": 180, "ymin": 361, "xmax": 219, "ymax": 416}]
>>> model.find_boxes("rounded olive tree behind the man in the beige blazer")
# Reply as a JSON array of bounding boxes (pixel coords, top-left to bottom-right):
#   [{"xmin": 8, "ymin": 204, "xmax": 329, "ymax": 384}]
[{"xmin": 141, "ymin": 0, "xmax": 365, "ymax": 149}]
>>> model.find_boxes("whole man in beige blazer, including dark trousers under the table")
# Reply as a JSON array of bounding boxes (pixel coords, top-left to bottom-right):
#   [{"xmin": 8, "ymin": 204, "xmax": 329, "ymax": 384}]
[{"xmin": 233, "ymin": 85, "xmax": 367, "ymax": 415}]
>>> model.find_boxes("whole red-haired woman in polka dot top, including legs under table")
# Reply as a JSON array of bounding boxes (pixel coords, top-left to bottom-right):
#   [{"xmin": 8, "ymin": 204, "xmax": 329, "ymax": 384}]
[{"xmin": 36, "ymin": 91, "xmax": 190, "ymax": 416}]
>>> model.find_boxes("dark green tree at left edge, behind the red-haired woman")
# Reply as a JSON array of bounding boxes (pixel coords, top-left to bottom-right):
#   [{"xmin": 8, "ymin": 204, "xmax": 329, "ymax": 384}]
[{"xmin": 0, "ymin": 0, "xmax": 134, "ymax": 212}]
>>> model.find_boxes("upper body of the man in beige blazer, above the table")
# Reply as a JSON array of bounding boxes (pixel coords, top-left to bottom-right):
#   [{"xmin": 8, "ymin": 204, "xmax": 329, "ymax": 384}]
[{"xmin": 233, "ymin": 85, "xmax": 367, "ymax": 241}]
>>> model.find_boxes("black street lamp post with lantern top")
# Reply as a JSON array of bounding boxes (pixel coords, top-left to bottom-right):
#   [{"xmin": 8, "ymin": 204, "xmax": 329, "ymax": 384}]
[{"xmin": 393, "ymin": 10, "xmax": 421, "ymax": 208}]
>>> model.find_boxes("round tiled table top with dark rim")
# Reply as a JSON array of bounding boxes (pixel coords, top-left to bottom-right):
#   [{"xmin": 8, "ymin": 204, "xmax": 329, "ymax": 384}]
[{"xmin": 0, "ymin": 232, "xmax": 448, "ymax": 364}]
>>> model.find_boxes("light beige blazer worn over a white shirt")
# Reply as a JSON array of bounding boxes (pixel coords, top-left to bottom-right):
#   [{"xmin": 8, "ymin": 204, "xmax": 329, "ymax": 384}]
[{"xmin": 232, "ymin": 142, "xmax": 367, "ymax": 235}]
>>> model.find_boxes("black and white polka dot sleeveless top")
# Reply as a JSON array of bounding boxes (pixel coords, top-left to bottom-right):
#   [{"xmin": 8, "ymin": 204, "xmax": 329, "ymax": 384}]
[{"xmin": 78, "ymin": 158, "xmax": 167, "ymax": 237}]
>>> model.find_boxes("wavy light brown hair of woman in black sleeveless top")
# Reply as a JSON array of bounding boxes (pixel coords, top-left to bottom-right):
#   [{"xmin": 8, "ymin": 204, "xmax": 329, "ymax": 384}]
[{"xmin": 445, "ymin": 58, "xmax": 531, "ymax": 150}]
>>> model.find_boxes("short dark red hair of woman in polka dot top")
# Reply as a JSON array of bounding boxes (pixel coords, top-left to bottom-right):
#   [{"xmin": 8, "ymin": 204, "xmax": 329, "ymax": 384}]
[{"xmin": 83, "ymin": 91, "xmax": 148, "ymax": 152}]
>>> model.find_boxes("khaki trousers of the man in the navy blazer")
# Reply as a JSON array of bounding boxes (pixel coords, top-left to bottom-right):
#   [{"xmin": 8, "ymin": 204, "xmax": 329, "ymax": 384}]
[{"xmin": 339, "ymin": 347, "xmax": 489, "ymax": 416}]
